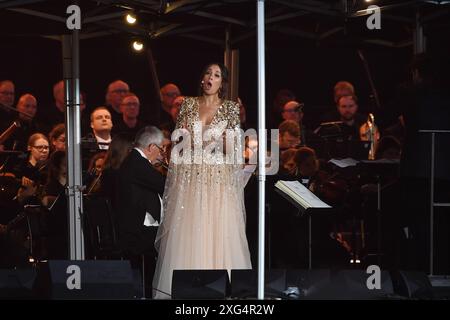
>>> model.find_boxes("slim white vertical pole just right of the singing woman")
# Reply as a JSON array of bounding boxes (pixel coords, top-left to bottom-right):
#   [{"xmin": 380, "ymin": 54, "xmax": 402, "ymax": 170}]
[{"xmin": 257, "ymin": 0, "xmax": 267, "ymax": 300}]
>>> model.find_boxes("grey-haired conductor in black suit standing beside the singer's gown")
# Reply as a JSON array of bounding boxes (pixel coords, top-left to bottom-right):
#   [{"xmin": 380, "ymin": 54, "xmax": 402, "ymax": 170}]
[{"xmin": 116, "ymin": 126, "xmax": 165, "ymax": 294}]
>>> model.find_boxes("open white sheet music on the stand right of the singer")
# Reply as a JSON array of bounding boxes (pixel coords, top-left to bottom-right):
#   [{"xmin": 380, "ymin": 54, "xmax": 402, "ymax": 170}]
[{"xmin": 275, "ymin": 180, "xmax": 331, "ymax": 209}]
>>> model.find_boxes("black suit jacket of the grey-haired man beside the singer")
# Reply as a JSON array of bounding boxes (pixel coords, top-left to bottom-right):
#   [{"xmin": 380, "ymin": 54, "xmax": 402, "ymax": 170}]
[{"xmin": 116, "ymin": 149, "xmax": 165, "ymax": 253}]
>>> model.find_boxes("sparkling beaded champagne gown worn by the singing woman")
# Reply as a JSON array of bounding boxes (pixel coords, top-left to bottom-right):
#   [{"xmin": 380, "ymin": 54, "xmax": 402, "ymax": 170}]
[{"xmin": 153, "ymin": 97, "xmax": 251, "ymax": 299}]
